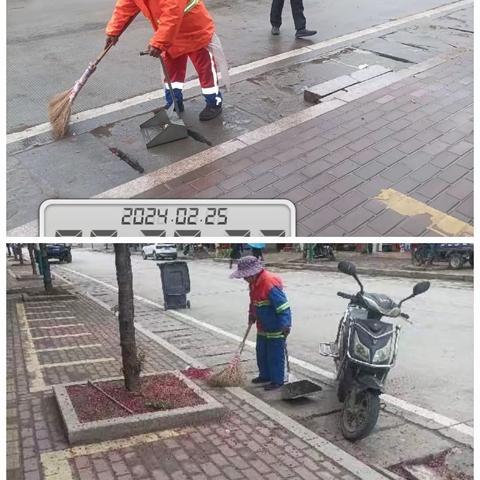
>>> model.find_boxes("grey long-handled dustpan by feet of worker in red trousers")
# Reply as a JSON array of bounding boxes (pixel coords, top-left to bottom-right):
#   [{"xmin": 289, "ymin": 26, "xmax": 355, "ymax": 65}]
[{"xmin": 140, "ymin": 52, "xmax": 188, "ymax": 148}]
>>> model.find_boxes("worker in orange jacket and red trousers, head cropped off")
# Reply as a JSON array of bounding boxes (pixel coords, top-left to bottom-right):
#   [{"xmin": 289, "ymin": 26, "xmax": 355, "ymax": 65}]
[{"xmin": 106, "ymin": 0, "xmax": 222, "ymax": 121}]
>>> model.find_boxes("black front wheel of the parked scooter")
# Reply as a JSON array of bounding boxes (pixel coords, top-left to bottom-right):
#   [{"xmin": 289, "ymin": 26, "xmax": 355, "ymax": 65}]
[{"xmin": 340, "ymin": 390, "xmax": 380, "ymax": 442}]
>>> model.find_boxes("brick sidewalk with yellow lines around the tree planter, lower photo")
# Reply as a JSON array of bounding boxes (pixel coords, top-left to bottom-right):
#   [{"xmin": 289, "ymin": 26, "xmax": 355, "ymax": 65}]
[{"xmin": 7, "ymin": 266, "xmax": 384, "ymax": 480}]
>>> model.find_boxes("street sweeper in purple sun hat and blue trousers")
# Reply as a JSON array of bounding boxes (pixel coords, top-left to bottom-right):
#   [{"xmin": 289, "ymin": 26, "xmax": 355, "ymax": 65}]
[{"xmin": 231, "ymin": 256, "xmax": 292, "ymax": 390}]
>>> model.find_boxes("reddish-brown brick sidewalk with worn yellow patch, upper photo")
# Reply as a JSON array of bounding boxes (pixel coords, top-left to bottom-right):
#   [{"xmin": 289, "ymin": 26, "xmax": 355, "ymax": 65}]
[{"xmin": 145, "ymin": 52, "xmax": 473, "ymax": 236}]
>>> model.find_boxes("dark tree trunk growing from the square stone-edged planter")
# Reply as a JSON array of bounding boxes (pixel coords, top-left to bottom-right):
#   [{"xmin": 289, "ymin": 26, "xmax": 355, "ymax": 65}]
[{"xmin": 114, "ymin": 243, "xmax": 141, "ymax": 392}]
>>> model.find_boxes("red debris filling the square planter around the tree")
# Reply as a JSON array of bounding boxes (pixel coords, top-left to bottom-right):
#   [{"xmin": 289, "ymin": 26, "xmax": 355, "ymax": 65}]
[{"xmin": 67, "ymin": 374, "xmax": 205, "ymax": 423}]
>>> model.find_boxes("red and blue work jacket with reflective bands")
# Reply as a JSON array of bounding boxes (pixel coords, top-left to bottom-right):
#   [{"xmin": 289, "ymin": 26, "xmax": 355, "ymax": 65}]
[{"xmin": 250, "ymin": 270, "xmax": 292, "ymax": 338}]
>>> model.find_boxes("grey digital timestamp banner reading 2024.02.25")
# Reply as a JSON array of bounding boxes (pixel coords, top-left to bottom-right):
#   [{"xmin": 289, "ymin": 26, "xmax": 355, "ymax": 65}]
[{"xmin": 39, "ymin": 199, "xmax": 295, "ymax": 237}]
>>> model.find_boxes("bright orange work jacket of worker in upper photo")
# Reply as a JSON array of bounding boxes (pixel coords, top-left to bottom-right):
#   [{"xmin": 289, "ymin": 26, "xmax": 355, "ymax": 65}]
[{"xmin": 106, "ymin": 0, "xmax": 215, "ymax": 58}]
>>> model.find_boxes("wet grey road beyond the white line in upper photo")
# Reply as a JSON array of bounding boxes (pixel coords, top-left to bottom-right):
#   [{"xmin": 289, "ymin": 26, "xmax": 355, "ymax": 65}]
[{"xmin": 7, "ymin": 0, "xmax": 458, "ymax": 132}]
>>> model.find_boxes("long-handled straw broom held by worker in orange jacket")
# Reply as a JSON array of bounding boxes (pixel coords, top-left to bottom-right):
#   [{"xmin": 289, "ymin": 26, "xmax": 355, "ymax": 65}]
[{"xmin": 48, "ymin": 15, "xmax": 137, "ymax": 139}]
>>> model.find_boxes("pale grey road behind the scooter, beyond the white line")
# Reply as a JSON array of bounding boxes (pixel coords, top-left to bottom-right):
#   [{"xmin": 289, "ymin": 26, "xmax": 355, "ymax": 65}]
[{"xmin": 55, "ymin": 250, "xmax": 473, "ymax": 421}]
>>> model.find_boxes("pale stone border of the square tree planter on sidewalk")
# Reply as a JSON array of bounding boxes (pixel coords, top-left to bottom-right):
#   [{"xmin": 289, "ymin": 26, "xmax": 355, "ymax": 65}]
[{"xmin": 53, "ymin": 371, "xmax": 225, "ymax": 445}]
